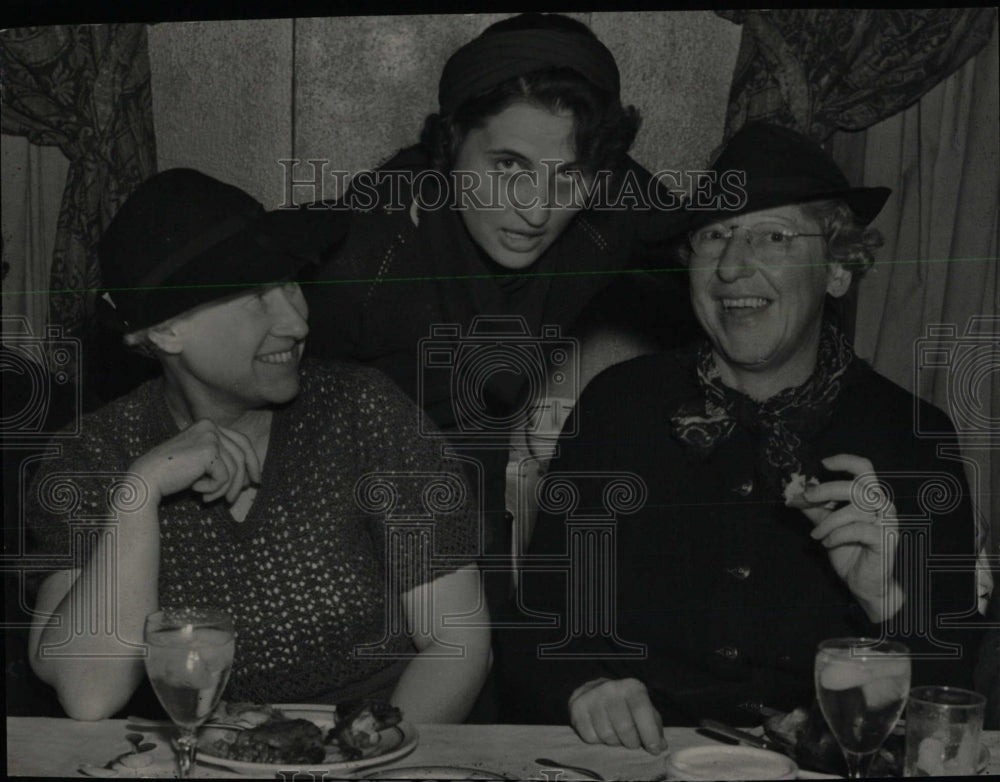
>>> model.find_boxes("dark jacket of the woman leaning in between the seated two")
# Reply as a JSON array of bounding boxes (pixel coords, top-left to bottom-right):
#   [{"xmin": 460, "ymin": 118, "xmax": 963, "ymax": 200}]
[{"xmin": 304, "ymin": 147, "xmax": 694, "ymax": 431}]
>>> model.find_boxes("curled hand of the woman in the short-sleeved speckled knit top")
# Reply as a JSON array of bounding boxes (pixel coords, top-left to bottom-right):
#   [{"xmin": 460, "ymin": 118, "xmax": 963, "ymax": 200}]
[{"xmin": 130, "ymin": 419, "xmax": 261, "ymax": 505}]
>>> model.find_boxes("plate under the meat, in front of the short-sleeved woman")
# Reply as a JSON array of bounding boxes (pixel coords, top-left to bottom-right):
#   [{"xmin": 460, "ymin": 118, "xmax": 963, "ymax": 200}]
[{"xmin": 198, "ymin": 703, "xmax": 418, "ymax": 777}]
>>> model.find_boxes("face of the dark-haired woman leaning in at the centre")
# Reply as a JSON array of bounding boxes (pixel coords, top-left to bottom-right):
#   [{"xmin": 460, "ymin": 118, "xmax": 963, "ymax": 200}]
[{"xmin": 453, "ymin": 101, "xmax": 583, "ymax": 270}]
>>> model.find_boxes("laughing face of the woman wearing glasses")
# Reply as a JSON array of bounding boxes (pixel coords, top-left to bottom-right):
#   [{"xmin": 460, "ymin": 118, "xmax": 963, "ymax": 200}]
[{"xmin": 690, "ymin": 205, "xmax": 851, "ymax": 396}]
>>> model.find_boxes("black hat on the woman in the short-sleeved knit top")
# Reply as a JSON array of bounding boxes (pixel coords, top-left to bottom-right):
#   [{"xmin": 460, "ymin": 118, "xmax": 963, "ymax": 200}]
[{"xmin": 97, "ymin": 168, "xmax": 348, "ymax": 332}]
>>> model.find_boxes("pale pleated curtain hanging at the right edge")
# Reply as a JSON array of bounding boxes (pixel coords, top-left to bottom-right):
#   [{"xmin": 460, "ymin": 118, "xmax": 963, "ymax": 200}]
[{"xmin": 833, "ymin": 17, "xmax": 1000, "ymax": 608}]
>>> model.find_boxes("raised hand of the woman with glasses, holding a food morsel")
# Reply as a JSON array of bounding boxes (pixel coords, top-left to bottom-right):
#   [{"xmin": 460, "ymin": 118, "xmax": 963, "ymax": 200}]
[{"xmin": 802, "ymin": 454, "xmax": 902, "ymax": 622}]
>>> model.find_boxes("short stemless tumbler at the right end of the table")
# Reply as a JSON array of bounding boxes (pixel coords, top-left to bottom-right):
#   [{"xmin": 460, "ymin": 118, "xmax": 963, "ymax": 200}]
[{"xmin": 904, "ymin": 687, "xmax": 986, "ymax": 777}]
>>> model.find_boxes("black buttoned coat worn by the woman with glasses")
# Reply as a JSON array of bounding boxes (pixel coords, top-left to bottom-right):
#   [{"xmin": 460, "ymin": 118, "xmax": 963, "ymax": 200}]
[{"xmin": 497, "ymin": 351, "xmax": 976, "ymax": 725}]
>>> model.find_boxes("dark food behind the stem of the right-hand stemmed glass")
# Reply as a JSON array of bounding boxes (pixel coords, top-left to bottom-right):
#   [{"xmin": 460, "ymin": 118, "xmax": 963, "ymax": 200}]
[{"xmin": 764, "ymin": 702, "xmax": 906, "ymax": 777}]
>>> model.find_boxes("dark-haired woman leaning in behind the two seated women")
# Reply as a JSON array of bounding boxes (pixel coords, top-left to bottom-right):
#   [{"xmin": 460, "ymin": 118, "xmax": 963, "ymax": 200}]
[{"xmin": 304, "ymin": 13, "xmax": 693, "ymax": 620}]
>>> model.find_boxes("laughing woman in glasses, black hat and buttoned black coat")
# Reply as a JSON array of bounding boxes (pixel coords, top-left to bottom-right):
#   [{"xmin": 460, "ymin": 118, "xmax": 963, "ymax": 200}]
[{"xmin": 498, "ymin": 124, "xmax": 976, "ymax": 752}]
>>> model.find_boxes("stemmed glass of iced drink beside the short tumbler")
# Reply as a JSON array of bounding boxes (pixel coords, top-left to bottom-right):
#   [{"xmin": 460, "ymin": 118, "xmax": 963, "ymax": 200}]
[{"xmin": 816, "ymin": 638, "xmax": 910, "ymax": 779}]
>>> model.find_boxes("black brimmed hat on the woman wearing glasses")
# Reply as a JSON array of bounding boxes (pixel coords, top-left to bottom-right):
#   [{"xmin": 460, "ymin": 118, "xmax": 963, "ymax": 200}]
[{"xmin": 684, "ymin": 122, "xmax": 892, "ymax": 231}]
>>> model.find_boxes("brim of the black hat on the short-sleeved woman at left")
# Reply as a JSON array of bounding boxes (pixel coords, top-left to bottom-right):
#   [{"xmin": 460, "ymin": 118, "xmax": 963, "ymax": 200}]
[{"xmin": 104, "ymin": 209, "xmax": 348, "ymax": 331}]
